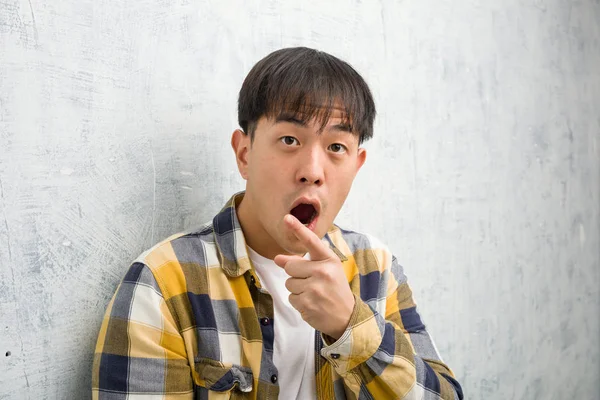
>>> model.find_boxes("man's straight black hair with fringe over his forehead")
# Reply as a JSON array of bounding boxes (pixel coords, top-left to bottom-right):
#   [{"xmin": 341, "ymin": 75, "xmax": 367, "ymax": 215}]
[{"xmin": 238, "ymin": 47, "xmax": 376, "ymax": 143}]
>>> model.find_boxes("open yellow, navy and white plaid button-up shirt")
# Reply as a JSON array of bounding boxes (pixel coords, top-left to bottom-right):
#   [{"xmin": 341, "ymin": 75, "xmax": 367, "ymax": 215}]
[{"xmin": 92, "ymin": 193, "xmax": 463, "ymax": 400}]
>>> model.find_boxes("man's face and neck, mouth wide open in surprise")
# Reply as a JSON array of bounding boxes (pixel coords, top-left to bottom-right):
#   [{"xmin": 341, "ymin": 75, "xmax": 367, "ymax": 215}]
[{"xmin": 232, "ymin": 112, "xmax": 366, "ymax": 258}]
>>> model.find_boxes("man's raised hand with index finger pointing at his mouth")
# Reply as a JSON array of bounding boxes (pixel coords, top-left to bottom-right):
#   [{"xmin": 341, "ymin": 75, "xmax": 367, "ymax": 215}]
[{"xmin": 274, "ymin": 214, "xmax": 354, "ymax": 340}]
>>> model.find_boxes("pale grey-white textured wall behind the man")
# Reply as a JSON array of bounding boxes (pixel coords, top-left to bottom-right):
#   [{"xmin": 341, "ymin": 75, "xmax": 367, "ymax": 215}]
[{"xmin": 0, "ymin": 0, "xmax": 600, "ymax": 400}]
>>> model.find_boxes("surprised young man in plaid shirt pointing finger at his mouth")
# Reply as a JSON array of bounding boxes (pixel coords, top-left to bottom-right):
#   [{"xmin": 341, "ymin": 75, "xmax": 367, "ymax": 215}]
[{"xmin": 92, "ymin": 48, "xmax": 463, "ymax": 400}]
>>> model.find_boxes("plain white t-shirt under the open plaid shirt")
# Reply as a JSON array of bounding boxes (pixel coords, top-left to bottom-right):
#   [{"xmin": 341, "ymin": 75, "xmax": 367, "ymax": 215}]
[{"xmin": 248, "ymin": 247, "xmax": 317, "ymax": 400}]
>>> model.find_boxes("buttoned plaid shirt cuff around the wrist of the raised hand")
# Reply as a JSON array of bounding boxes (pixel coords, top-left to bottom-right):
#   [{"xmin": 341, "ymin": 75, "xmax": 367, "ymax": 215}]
[{"xmin": 321, "ymin": 295, "xmax": 385, "ymax": 376}]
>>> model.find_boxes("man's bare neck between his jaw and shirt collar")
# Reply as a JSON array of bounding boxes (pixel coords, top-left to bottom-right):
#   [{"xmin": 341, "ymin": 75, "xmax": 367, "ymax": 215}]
[{"xmin": 236, "ymin": 192, "xmax": 289, "ymax": 260}]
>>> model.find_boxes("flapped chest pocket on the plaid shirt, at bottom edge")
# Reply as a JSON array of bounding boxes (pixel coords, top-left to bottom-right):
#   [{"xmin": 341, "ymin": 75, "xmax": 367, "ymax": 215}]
[{"xmin": 194, "ymin": 358, "xmax": 253, "ymax": 400}]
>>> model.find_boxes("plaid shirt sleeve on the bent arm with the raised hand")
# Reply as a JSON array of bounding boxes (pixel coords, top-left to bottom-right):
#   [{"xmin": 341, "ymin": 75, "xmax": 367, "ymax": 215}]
[{"xmin": 321, "ymin": 257, "xmax": 463, "ymax": 400}]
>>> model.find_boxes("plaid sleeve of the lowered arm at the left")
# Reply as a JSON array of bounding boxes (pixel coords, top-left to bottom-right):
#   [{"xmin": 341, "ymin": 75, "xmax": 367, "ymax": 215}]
[{"xmin": 92, "ymin": 263, "xmax": 193, "ymax": 400}]
